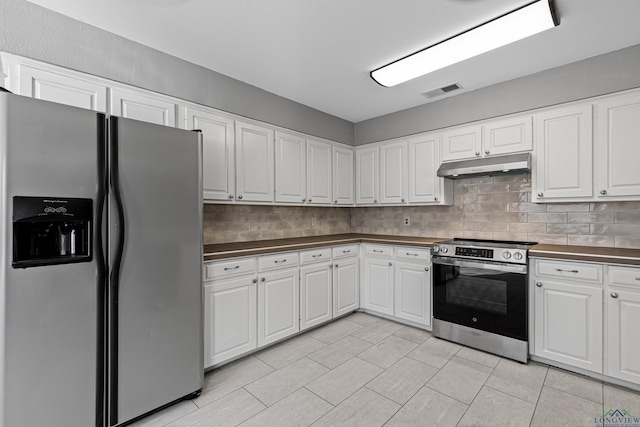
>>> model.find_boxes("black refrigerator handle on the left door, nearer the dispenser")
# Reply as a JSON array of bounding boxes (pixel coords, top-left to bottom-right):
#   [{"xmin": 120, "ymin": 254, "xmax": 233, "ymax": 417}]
[{"xmin": 93, "ymin": 113, "xmax": 108, "ymax": 427}]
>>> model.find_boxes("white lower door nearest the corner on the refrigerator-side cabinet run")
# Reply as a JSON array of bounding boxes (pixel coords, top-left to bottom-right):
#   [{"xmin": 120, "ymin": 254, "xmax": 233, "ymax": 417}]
[{"xmin": 333, "ymin": 258, "xmax": 360, "ymax": 317}]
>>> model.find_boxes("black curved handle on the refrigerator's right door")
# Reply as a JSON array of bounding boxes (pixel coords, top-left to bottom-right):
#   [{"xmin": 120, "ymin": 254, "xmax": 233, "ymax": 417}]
[{"xmin": 109, "ymin": 116, "xmax": 126, "ymax": 425}]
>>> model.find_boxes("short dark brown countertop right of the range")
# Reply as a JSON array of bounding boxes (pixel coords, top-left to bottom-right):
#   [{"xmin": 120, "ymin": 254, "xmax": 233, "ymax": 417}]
[{"xmin": 529, "ymin": 245, "xmax": 640, "ymax": 265}]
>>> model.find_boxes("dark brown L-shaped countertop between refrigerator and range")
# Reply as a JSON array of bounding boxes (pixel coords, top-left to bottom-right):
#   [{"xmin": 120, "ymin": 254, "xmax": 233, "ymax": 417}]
[{"xmin": 204, "ymin": 233, "xmax": 446, "ymax": 261}]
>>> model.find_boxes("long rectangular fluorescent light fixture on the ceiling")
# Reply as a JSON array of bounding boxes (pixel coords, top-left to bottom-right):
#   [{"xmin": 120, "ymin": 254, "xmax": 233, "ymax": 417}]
[{"xmin": 371, "ymin": 0, "xmax": 558, "ymax": 87}]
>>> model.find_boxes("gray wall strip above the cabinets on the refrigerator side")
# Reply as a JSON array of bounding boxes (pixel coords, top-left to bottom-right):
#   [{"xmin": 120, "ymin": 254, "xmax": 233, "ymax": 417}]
[{"xmin": 0, "ymin": 0, "xmax": 354, "ymax": 144}]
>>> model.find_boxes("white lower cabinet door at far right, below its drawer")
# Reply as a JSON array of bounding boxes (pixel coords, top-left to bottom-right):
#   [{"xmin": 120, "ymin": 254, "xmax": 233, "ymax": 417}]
[{"xmin": 606, "ymin": 288, "xmax": 640, "ymax": 384}]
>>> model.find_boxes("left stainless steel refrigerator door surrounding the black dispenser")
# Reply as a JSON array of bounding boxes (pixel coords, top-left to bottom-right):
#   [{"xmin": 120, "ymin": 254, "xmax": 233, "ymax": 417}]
[{"xmin": 0, "ymin": 94, "xmax": 104, "ymax": 427}]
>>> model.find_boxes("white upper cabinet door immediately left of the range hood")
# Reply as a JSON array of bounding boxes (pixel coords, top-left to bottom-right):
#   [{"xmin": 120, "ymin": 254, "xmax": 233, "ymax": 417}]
[{"xmin": 409, "ymin": 133, "xmax": 444, "ymax": 203}]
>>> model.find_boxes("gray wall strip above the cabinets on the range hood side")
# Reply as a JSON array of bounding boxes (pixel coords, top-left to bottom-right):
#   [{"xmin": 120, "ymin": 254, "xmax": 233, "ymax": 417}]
[{"xmin": 355, "ymin": 45, "xmax": 640, "ymax": 145}]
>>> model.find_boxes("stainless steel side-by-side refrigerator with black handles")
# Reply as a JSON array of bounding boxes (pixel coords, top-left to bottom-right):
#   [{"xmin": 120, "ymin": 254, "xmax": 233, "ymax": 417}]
[{"xmin": 0, "ymin": 93, "xmax": 203, "ymax": 427}]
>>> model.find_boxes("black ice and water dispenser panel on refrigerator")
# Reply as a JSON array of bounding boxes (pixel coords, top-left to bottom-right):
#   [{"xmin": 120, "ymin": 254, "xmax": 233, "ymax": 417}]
[{"xmin": 11, "ymin": 196, "xmax": 93, "ymax": 268}]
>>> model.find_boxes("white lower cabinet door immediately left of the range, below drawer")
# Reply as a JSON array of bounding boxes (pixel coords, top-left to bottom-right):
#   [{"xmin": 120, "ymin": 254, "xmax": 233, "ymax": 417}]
[{"xmin": 393, "ymin": 262, "xmax": 431, "ymax": 326}]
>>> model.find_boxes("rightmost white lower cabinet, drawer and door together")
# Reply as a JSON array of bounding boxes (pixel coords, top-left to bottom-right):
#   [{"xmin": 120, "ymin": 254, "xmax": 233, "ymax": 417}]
[{"xmin": 605, "ymin": 266, "xmax": 640, "ymax": 384}]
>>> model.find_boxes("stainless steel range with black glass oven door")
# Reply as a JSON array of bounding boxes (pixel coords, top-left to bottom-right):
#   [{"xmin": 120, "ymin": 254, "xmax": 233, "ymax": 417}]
[{"xmin": 432, "ymin": 239, "xmax": 535, "ymax": 363}]
